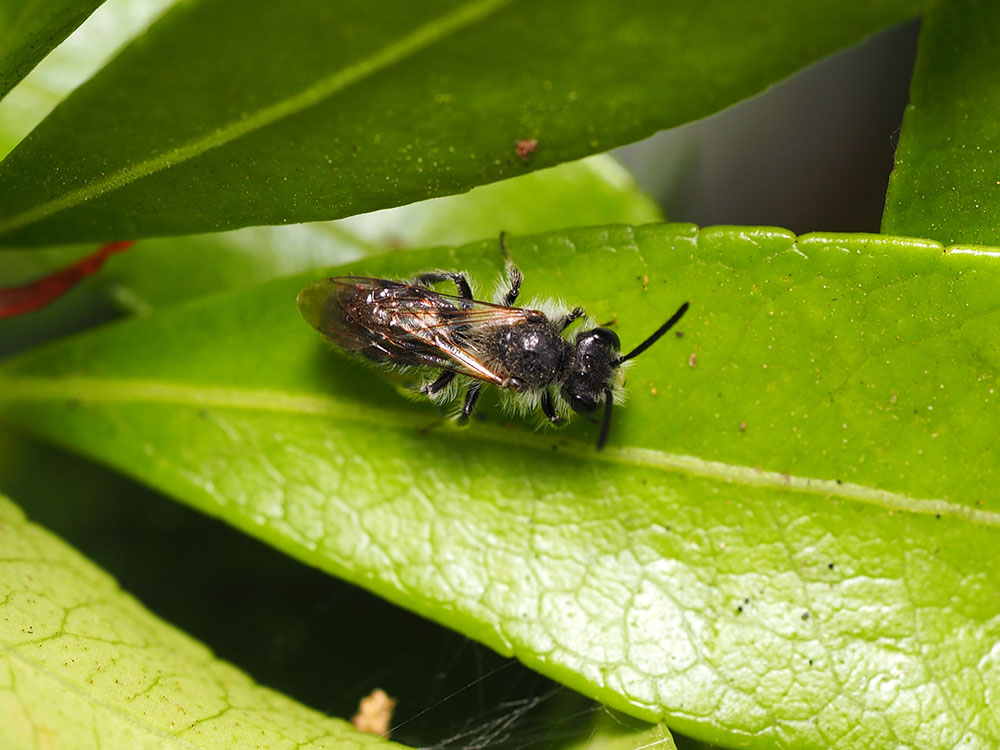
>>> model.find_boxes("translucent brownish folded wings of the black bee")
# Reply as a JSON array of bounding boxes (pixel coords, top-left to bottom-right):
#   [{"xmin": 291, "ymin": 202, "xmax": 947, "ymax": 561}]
[{"xmin": 298, "ymin": 276, "xmax": 538, "ymax": 385}]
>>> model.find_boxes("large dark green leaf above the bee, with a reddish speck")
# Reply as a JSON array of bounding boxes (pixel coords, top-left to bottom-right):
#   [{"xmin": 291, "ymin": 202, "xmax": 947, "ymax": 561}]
[{"xmin": 0, "ymin": 0, "xmax": 921, "ymax": 244}]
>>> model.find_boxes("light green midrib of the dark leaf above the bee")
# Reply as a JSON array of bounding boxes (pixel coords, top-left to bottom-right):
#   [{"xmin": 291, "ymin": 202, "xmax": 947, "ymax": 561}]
[{"xmin": 0, "ymin": 0, "xmax": 513, "ymax": 234}]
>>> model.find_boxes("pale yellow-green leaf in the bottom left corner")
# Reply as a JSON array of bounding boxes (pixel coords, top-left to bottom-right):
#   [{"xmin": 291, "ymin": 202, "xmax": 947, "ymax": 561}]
[{"xmin": 0, "ymin": 496, "xmax": 410, "ymax": 750}]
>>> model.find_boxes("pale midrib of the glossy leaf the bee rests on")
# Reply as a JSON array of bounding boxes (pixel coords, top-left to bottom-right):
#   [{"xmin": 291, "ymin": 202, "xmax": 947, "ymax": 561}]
[{"xmin": 0, "ymin": 376, "xmax": 1000, "ymax": 527}]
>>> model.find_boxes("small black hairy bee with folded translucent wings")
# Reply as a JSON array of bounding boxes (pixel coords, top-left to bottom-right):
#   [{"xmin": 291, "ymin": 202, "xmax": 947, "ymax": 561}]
[{"xmin": 298, "ymin": 241, "xmax": 688, "ymax": 450}]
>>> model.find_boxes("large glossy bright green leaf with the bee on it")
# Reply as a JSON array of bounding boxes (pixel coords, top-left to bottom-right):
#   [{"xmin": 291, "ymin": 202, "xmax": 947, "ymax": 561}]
[{"xmin": 0, "ymin": 225, "xmax": 1000, "ymax": 749}]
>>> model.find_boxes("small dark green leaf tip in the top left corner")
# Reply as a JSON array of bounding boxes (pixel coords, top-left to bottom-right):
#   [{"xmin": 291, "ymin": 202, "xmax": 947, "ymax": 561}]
[{"xmin": 0, "ymin": 0, "xmax": 103, "ymax": 99}]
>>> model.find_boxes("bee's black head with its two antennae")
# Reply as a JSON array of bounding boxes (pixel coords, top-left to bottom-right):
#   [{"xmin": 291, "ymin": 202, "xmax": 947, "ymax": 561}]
[{"xmin": 561, "ymin": 302, "xmax": 688, "ymax": 450}]
